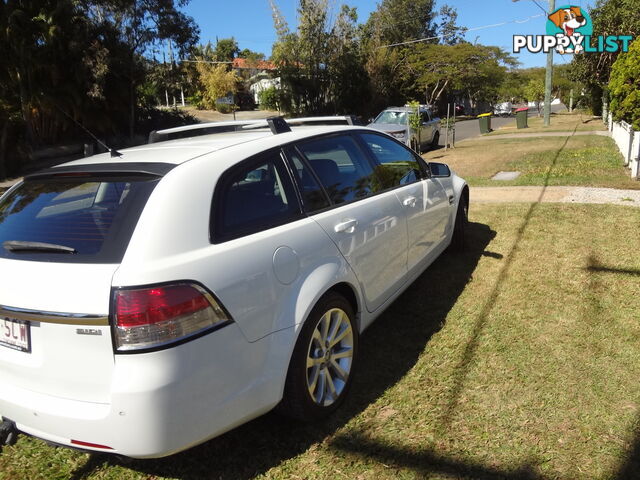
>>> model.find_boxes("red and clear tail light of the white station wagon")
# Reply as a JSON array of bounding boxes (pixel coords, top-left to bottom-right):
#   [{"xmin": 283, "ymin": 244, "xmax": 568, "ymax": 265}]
[{"xmin": 113, "ymin": 283, "xmax": 231, "ymax": 351}]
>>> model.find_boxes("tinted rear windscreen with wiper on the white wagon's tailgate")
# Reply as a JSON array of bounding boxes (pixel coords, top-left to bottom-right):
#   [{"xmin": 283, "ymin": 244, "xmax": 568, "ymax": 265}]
[{"xmin": 0, "ymin": 175, "xmax": 159, "ymax": 263}]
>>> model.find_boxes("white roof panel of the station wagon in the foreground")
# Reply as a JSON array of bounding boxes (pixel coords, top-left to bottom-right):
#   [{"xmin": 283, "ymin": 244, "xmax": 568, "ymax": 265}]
[{"xmin": 55, "ymin": 117, "xmax": 366, "ymax": 168}]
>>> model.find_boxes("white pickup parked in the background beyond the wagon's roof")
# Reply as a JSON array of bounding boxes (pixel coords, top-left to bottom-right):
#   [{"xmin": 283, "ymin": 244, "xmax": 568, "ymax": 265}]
[{"xmin": 368, "ymin": 105, "xmax": 440, "ymax": 151}]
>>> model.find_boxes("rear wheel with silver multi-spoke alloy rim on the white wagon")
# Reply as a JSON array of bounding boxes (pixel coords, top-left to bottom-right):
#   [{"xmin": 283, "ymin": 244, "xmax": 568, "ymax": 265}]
[{"xmin": 277, "ymin": 292, "xmax": 358, "ymax": 421}]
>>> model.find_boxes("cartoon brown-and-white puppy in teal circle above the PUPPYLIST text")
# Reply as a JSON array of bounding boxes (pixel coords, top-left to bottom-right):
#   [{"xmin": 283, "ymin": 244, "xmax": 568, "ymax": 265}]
[{"xmin": 547, "ymin": 5, "xmax": 593, "ymax": 54}]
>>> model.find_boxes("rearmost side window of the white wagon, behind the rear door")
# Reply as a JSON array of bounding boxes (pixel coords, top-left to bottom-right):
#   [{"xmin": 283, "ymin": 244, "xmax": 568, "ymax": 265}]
[{"xmin": 212, "ymin": 152, "xmax": 301, "ymax": 243}]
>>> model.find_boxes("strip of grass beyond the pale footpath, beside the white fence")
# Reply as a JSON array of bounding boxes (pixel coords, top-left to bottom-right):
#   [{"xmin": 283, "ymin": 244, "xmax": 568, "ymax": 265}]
[{"xmin": 424, "ymin": 135, "xmax": 640, "ymax": 189}]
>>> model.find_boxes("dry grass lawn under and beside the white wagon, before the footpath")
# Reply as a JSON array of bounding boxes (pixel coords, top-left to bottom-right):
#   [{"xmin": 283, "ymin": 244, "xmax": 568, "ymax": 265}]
[{"xmin": 0, "ymin": 204, "xmax": 640, "ymax": 480}]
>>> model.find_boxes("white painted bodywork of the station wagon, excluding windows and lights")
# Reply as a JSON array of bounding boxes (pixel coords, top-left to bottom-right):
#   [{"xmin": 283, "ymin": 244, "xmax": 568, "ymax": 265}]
[{"xmin": 0, "ymin": 119, "xmax": 466, "ymax": 458}]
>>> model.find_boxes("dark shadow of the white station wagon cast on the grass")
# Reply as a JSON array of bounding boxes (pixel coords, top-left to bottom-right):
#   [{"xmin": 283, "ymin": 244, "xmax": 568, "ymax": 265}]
[{"xmin": 72, "ymin": 223, "xmax": 499, "ymax": 480}]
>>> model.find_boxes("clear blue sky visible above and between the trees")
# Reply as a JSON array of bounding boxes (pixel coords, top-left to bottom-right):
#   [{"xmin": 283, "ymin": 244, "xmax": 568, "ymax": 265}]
[{"xmin": 184, "ymin": 0, "xmax": 595, "ymax": 68}]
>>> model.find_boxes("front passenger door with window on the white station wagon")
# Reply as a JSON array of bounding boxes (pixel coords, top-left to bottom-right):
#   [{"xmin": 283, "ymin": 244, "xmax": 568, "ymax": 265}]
[{"xmin": 359, "ymin": 133, "xmax": 450, "ymax": 276}]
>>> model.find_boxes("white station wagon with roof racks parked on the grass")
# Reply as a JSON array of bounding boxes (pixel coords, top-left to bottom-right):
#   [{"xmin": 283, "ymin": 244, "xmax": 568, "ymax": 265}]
[{"xmin": 0, "ymin": 117, "xmax": 469, "ymax": 458}]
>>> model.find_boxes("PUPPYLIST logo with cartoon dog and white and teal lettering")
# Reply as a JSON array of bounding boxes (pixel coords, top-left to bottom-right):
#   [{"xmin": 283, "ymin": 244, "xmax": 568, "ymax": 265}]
[{"xmin": 513, "ymin": 5, "xmax": 633, "ymax": 54}]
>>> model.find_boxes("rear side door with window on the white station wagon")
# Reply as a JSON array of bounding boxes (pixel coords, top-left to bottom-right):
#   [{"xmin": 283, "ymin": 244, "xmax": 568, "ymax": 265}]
[{"xmin": 298, "ymin": 134, "xmax": 407, "ymax": 312}]
